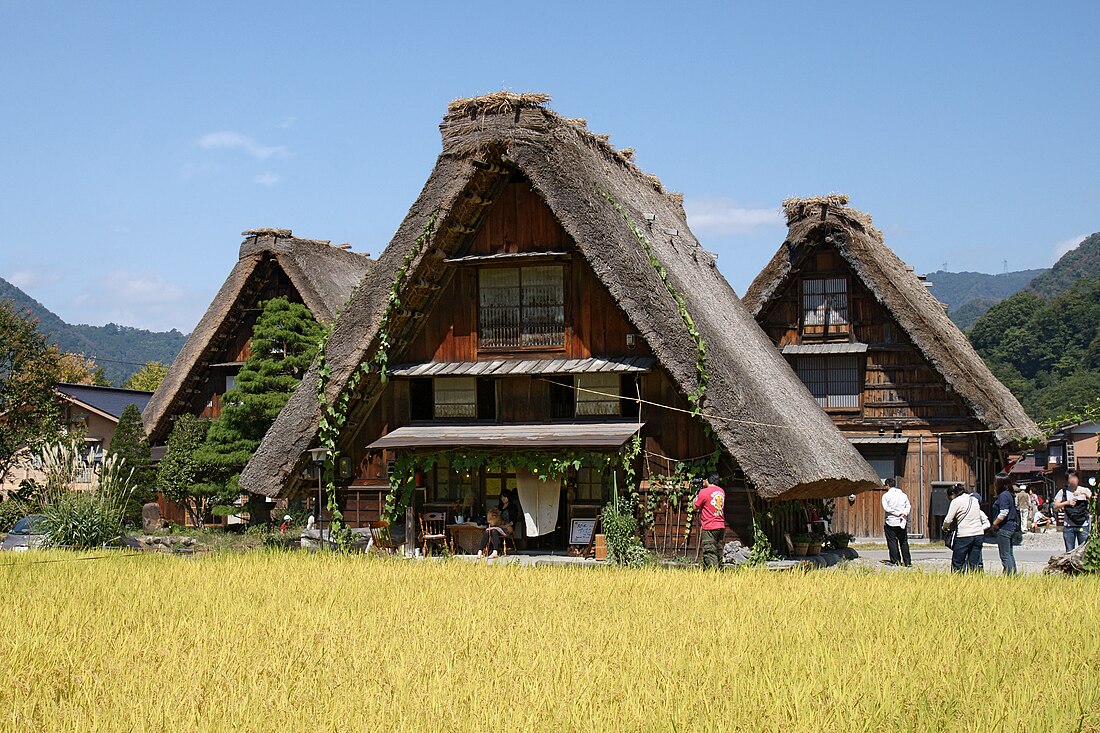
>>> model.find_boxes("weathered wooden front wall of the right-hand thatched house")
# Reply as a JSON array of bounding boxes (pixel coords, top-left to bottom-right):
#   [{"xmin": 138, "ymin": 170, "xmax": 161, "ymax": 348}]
[{"xmin": 757, "ymin": 244, "xmax": 1004, "ymax": 537}]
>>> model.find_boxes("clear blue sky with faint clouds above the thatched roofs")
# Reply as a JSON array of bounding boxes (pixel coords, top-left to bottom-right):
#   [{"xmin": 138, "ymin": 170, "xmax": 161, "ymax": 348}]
[{"xmin": 0, "ymin": 0, "xmax": 1100, "ymax": 332}]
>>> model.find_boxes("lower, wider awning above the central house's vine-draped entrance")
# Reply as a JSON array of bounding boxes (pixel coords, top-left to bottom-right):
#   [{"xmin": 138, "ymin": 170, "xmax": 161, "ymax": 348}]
[{"xmin": 366, "ymin": 423, "xmax": 644, "ymax": 450}]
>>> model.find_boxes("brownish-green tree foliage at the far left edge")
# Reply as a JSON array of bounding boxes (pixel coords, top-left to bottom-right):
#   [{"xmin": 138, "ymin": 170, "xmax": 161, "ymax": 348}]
[{"xmin": 0, "ymin": 302, "xmax": 61, "ymax": 479}]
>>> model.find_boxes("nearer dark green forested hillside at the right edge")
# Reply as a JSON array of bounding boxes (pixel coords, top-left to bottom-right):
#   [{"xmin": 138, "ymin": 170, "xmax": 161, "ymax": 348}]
[{"xmin": 969, "ymin": 228, "xmax": 1100, "ymax": 420}]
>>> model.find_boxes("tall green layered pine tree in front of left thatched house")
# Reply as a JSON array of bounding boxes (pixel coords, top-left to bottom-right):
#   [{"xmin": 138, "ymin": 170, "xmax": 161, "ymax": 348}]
[{"xmin": 198, "ymin": 297, "xmax": 322, "ymax": 508}]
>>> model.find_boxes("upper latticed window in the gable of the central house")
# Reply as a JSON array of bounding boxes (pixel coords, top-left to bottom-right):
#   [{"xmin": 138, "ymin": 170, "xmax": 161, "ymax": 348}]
[{"xmin": 477, "ymin": 265, "xmax": 565, "ymax": 349}]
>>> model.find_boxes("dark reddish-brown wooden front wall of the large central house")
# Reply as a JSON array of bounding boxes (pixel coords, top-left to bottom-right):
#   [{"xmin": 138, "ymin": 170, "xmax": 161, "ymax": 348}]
[{"xmin": 330, "ymin": 181, "xmax": 750, "ymax": 553}]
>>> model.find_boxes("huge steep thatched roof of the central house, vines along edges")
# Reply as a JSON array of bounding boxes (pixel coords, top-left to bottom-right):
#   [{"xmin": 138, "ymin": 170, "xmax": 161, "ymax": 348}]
[{"xmin": 241, "ymin": 91, "xmax": 878, "ymax": 497}]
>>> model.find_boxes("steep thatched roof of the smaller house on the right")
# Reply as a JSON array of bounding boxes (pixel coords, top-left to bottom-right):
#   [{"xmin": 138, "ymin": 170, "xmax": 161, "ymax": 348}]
[{"xmin": 744, "ymin": 194, "xmax": 1041, "ymax": 446}]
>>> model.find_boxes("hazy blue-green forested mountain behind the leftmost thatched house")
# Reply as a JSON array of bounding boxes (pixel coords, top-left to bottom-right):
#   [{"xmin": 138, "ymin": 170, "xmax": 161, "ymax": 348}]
[{"xmin": 0, "ymin": 277, "xmax": 187, "ymax": 385}]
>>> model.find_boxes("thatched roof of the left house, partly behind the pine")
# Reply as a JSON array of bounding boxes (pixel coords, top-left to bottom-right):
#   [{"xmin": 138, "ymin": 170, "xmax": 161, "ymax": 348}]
[{"xmin": 142, "ymin": 229, "xmax": 371, "ymax": 442}]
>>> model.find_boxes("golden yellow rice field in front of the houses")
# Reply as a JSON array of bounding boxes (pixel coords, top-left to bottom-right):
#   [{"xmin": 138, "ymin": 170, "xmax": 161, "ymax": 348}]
[{"xmin": 0, "ymin": 553, "xmax": 1100, "ymax": 733}]
